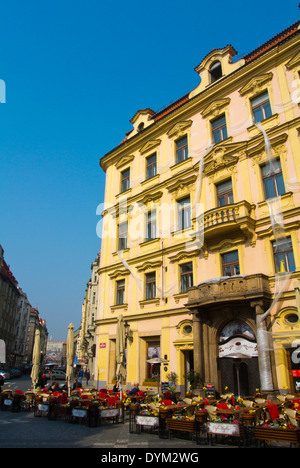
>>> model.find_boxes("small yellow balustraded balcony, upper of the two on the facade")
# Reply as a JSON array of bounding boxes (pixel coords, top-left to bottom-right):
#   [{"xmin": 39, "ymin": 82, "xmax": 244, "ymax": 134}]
[{"xmin": 204, "ymin": 200, "xmax": 255, "ymax": 245}]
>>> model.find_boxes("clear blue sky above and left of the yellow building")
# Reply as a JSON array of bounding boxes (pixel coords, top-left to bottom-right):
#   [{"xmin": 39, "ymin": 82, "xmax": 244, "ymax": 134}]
[{"xmin": 0, "ymin": 0, "xmax": 300, "ymax": 340}]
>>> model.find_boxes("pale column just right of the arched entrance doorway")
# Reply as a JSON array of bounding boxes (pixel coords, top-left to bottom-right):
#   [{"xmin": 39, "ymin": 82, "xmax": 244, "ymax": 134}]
[{"xmin": 251, "ymin": 301, "xmax": 274, "ymax": 392}]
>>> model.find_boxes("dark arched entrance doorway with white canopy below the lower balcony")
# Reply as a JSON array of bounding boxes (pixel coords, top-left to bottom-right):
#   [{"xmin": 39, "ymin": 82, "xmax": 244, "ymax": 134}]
[{"xmin": 218, "ymin": 320, "xmax": 259, "ymax": 396}]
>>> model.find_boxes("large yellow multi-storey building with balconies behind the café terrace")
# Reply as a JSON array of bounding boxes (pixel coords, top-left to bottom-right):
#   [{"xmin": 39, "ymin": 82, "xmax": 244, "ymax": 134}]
[{"xmin": 94, "ymin": 22, "xmax": 300, "ymax": 394}]
